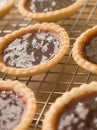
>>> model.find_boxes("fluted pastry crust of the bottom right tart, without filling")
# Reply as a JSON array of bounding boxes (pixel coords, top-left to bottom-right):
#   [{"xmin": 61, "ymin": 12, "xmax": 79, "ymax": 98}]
[{"xmin": 42, "ymin": 81, "xmax": 97, "ymax": 130}]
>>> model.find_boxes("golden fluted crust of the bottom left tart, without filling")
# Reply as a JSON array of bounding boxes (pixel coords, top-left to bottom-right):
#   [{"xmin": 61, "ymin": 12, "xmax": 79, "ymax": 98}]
[{"xmin": 0, "ymin": 80, "xmax": 36, "ymax": 130}]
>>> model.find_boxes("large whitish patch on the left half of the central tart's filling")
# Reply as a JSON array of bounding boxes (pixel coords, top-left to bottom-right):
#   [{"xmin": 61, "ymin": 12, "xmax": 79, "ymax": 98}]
[{"xmin": 4, "ymin": 36, "xmax": 35, "ymax": 67}]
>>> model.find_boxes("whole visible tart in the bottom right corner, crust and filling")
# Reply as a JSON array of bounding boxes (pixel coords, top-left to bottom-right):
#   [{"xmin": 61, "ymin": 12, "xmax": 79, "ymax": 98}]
[{"xmin": 42, "ymin": 81, "xmax": 97, "ymax": 130}]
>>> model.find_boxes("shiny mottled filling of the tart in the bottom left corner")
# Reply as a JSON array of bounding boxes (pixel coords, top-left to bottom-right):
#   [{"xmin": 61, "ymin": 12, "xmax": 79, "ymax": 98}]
[{"xmin": 0, "ymin": 91, "xmax": 24, "ymax": 130}]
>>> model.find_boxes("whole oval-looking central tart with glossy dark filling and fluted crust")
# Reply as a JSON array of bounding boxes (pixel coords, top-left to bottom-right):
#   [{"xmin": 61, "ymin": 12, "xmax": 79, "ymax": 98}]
[{"xmin": 0, "ymin": 23, "xmax": 69, "ymax": 76}]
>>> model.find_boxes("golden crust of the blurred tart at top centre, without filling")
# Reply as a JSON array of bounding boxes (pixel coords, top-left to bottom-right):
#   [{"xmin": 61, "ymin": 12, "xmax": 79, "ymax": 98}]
[{"xmin": 19, "ymin": 0, "xmax": 86, "ymax": 22}]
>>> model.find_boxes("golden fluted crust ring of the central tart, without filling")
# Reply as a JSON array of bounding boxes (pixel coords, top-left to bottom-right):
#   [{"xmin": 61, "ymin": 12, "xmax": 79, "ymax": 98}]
[{"xmin": 0, "ymin": 23, "xmax": 69, "ymax": 76}]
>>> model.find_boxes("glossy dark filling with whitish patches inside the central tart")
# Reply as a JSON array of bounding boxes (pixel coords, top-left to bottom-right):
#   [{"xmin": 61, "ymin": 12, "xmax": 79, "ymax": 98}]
[{"xmin": 3, "ymin": 31, "xmax": 59, "ymax": 68}]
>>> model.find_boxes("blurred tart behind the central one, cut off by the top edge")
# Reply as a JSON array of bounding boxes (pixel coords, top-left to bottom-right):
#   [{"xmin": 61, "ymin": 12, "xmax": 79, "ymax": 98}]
[{"xmin": 19, "ymin": 0, "xmax": 86, "ymax": 22}]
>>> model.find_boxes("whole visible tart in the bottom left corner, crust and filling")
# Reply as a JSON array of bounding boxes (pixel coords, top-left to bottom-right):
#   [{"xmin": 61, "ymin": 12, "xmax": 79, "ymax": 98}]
[{"xmin": 0, "ymin": 80, "xmax": 36, "ymax": 130}]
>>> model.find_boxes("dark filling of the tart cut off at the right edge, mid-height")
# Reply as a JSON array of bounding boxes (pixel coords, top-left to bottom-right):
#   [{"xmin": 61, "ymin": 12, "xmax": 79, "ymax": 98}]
[{"xmin": 83, "ymin": 36, "xmax": 97, "ymax": 64}]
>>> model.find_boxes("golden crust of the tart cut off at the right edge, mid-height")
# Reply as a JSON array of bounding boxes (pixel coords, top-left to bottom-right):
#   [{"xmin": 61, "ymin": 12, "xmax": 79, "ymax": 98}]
[{"xmin": 72, "ymin": 26, "xmax": 97, "ymax": 74}]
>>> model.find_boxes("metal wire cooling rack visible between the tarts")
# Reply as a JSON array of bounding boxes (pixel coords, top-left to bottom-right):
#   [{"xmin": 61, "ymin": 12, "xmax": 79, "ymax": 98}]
[{"xmin": 0, "ymin": 0, "xmax": 97, "ymax": 130}]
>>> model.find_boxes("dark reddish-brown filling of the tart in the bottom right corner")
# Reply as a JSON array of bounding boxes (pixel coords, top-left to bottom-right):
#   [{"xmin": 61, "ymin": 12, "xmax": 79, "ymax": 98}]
[{"xmin": 57, "ymin": 93, "xmax": 97, "ymax": 130}]
